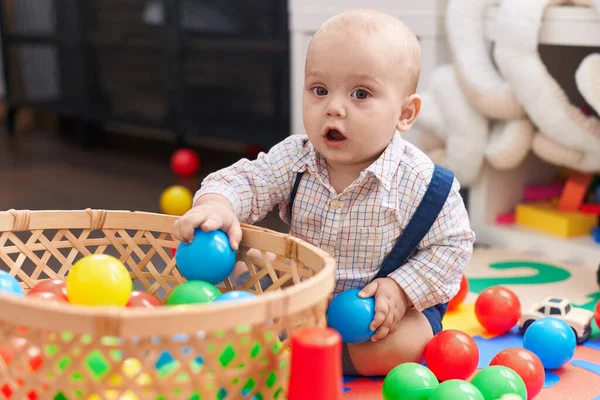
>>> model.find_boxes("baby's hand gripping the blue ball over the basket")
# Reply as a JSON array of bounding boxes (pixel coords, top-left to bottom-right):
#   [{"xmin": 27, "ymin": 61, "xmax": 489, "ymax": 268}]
[{"xmin": 173, "ymin": 195, "xmax": 242, "ymax": 250}]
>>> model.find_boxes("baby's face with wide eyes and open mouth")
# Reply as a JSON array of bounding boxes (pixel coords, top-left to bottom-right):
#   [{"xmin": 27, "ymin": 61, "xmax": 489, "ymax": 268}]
[{"xmin": 302, "ymin": 31, "xmax": 407, "ymax": 166}]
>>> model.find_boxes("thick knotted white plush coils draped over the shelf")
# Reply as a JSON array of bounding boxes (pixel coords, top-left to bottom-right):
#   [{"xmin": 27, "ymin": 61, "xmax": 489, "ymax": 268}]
[{"xmin": 416, "ymin": 0, "xmax": 600, "ymax": 186}]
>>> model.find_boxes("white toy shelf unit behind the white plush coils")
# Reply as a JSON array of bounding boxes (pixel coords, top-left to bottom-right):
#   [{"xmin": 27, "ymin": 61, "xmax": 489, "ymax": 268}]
[{"xmin": 469, "ymin": 6, "xmax": 600, "ymax": 266}]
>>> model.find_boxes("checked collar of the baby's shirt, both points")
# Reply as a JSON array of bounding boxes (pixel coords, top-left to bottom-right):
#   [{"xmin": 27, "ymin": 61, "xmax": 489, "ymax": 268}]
[{"xmin": 292, "ymin": 131, "xmax": 405, "ymax": 190}]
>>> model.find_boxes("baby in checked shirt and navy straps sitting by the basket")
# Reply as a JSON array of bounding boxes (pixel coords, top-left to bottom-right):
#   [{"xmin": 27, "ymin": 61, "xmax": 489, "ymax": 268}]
[{"xmin": 173, "ymin": 10, "xmax": 475, "ymax": 376}]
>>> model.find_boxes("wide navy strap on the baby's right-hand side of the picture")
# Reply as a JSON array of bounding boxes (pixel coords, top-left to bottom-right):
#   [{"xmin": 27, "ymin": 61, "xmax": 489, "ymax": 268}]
[{"xmin": 373, "ymin": 164, "xmax": 454, "ymax": 279}]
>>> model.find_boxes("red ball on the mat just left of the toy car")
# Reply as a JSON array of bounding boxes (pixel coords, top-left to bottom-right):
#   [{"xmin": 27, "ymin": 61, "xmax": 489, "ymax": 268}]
[{"xmin": 475, "ymin": 286, "xmax": 521, "ymax": 335}]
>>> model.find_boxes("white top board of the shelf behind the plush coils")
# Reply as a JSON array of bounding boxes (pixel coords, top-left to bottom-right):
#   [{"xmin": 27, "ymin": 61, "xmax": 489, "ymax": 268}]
[{"xmin": 484, "ymin": 6, "xmax": 600, "ymax": 47}]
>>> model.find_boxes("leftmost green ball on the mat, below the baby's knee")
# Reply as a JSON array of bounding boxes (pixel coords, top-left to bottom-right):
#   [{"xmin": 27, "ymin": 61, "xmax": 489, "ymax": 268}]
[{"xmin": 383, "ymin": 363, "xmax": 439, "ymax": 400}]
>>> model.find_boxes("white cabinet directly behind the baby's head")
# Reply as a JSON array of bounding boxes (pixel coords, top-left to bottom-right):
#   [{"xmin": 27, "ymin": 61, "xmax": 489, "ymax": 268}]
[{"xmin": 288, "ymin": 0, "xmax": 450, "ymax": 134}]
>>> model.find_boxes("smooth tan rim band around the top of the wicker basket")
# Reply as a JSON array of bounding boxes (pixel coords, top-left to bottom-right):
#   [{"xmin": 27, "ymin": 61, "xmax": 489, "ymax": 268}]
[{"xmin": 0, "ymin": 209, "xmax": 335, "ymax": 337}]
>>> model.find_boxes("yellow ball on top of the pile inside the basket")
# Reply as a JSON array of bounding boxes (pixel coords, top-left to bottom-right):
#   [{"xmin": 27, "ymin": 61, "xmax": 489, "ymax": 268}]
[{"xmin": 65, "ymin": 254, "xmax": 132, "ymax": 307}]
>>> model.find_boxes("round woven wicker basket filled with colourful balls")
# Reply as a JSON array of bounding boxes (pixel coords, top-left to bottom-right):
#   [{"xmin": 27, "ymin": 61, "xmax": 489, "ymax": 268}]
[{"xmin": 0, "ymin": 209, "xmax": 335, "ymax": 400}]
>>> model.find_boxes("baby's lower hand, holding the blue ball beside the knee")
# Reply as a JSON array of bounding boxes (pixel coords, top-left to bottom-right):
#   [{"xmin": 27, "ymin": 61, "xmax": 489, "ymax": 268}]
[{"xmin": 358, "ymin": 278, "xmax": 408, "ymax": 342}]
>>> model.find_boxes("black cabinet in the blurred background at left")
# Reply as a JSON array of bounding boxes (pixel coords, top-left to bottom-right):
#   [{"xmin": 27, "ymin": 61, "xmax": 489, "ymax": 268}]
[{"xmin": 0, "ymin": 0, "xmax": 289, "ymax": 146}]
